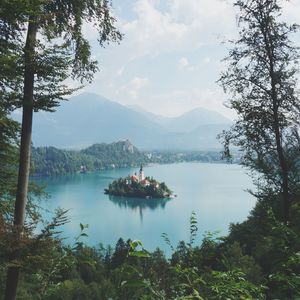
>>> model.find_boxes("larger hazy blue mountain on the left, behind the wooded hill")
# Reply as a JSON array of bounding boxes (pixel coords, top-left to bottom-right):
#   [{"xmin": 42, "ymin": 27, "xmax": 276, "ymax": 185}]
[{"xmin": 13, "ymin": 93, "xmax": 160, "ymax": 148}]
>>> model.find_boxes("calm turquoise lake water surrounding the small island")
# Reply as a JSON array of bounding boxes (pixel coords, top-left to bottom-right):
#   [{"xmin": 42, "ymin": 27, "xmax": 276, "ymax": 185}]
[{"xmin": 38, "ymin": 163, "xmax": 255, "ymax": 253}]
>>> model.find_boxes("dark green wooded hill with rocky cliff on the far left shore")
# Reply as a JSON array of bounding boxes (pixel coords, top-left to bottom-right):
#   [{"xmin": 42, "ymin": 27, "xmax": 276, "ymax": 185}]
[{"xmin": 32, "ymin": 140, "xmax": 148, "ymax": 176}]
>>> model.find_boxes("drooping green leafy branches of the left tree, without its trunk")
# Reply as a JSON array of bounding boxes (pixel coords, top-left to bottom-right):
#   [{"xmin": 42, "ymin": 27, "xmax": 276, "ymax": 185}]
[{"xmin": 0, "ymin": 0, "xmax": 122, "ymax": 111}]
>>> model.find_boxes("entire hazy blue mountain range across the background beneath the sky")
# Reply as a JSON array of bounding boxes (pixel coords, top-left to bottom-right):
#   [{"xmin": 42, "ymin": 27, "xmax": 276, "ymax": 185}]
[{"xmin": 14, "ymin": 93, "xmax": 231, "ymax": 150}]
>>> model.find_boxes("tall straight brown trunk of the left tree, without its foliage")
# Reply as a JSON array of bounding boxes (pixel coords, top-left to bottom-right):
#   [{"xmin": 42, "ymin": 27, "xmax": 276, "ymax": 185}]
[{"xmin": 4, "ymin": 18, "xmax": 38, "ymax": 300}]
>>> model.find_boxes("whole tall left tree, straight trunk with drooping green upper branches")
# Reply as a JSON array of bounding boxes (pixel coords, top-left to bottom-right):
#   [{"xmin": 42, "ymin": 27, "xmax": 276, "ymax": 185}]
[{"xmin": 0, "ymin": 0, "xmax": 121, "ymax": 299}]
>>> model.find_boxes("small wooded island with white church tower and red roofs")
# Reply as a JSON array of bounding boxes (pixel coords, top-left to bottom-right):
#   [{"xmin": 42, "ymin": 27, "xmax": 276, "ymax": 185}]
[{"xmin": 104, "ymin": 165, "xmax": 173, "ymax": 198}]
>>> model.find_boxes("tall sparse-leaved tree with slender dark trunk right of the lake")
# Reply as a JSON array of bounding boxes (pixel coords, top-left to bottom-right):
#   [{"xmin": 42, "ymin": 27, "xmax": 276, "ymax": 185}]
[{"xmin": 220, "ymin": 0, "xmax": 300, "ymax": 224}]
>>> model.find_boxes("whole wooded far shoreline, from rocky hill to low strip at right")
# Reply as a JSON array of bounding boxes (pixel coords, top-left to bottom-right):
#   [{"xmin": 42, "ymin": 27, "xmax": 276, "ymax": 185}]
[{"xmin": 32, "ymin": 140, "xmax": 227, "ymax": 176}]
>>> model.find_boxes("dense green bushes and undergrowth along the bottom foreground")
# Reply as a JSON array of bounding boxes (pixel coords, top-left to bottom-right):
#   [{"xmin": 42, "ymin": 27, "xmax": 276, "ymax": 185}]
[{"xmin": 0, "ymin": 206, "xmax": 300, "ymax": 300}]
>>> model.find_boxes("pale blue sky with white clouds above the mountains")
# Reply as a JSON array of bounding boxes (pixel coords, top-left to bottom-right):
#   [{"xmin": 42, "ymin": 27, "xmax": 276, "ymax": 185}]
[{"xmin": 79, "ymin": 0, "xmax": 300, "ymax": 119}]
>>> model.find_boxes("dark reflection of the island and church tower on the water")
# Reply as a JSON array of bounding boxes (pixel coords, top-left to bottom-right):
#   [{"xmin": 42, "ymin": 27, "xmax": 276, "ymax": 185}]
[{"xmin": 109, "ymin": 195, "xmax": 171, "ymax": 222}]
